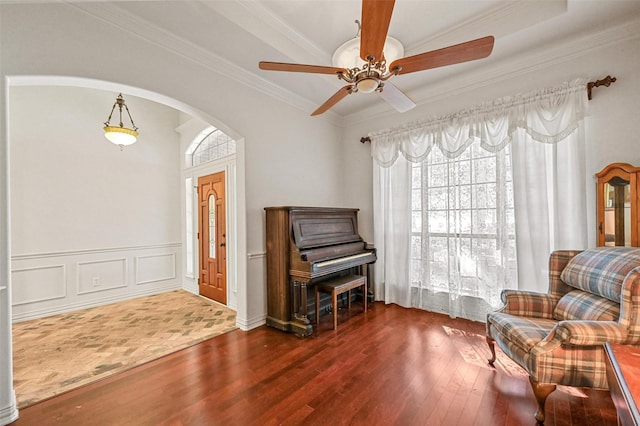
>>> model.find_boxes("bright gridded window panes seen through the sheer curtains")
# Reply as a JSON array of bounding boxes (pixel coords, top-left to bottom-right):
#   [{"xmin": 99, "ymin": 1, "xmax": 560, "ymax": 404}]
[{"xmin": 411, "ymin": 141, "xmax": 517, "ymax": 305}]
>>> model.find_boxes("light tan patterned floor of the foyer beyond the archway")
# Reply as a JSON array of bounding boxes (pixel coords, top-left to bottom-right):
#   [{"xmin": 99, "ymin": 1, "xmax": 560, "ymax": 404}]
[{"xmin": 13, "ymin": 290, "xmax": 236, "ymax": 408}]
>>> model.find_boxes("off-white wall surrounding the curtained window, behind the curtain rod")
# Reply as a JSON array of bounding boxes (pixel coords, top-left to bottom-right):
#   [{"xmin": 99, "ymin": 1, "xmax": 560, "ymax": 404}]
[{"xmin": 343, "ymin": 22, "xmax": 640, "ymax": 246}]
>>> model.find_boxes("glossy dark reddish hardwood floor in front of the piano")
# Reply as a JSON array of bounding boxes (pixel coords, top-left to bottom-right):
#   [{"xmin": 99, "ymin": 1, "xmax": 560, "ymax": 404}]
[{"xmin": 13, "ymin": 303, "xmax": 617, "ymax": 426}]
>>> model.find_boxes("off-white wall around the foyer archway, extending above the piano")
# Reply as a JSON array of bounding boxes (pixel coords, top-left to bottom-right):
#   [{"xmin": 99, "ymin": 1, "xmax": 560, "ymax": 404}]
[{"xmin": 0, "ymin": 4, "xmax": 343, "ymax": 340}]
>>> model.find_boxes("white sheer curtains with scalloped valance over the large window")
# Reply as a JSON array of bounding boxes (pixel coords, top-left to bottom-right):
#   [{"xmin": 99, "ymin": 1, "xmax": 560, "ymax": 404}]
[{"xmin": 369, "ymin": 80, "xmax": 587, "ymax": 320}]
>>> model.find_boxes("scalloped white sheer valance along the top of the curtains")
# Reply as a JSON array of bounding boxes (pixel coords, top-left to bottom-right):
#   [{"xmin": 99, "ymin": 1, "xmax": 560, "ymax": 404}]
[{"xmin": 369, "ymin": 79, "xmax": 587, "ymax": 167}]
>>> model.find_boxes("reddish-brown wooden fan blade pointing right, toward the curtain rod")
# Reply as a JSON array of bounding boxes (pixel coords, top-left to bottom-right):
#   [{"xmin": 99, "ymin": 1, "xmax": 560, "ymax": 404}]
[{"xmin": 389, "ymin": 36, "xmax": 494, "ymax": 74}]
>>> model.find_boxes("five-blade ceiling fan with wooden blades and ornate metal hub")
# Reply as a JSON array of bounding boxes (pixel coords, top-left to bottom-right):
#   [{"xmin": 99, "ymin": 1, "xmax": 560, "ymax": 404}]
[{"xmin": 258, "ymin": 0, "xmax": 494, "ymax": 116}]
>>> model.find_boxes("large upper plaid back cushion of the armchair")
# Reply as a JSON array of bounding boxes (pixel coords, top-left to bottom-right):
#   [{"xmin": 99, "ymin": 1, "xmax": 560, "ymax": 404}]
[{"xmin": 560, "ymin": 247, "xmax": 640, "ymax": 302}]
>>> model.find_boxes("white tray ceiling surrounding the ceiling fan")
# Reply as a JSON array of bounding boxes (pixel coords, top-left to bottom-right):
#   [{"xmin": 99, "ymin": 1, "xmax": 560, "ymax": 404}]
[{"xmin": 42, "ymin": 0, "xmax": 640, "ymax": 124}]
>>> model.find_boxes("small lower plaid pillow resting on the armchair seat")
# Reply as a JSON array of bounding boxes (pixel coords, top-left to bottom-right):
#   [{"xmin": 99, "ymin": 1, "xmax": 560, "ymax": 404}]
[{"xmin": 553, "ymin": 290, "xmax": 620, "ymax": 321}]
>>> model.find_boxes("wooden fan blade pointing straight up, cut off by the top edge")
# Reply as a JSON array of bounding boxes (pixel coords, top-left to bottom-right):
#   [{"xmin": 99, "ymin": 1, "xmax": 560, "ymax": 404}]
[{"xmin": 360, "ymin": 0, "xmax": 395, "ymax": 61}]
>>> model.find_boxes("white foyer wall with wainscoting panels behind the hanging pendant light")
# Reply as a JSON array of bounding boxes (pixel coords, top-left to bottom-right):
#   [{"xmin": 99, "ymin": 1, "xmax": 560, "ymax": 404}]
[{"xmin": 9, "ymin": 86, "xmax": 181, "ymax": 320}]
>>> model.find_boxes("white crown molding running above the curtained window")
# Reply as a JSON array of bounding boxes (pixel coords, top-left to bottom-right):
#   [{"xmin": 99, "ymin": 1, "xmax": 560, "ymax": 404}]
[{"xmin": 343, "ymin": 19, "xmax": 640, "ymax": 126}]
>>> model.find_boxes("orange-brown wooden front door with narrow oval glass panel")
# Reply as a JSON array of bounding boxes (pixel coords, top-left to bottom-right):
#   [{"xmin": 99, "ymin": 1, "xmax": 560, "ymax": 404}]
[{"xmin": 198, "ymin": 172, "xmax": 227, "ymax": 305}]
